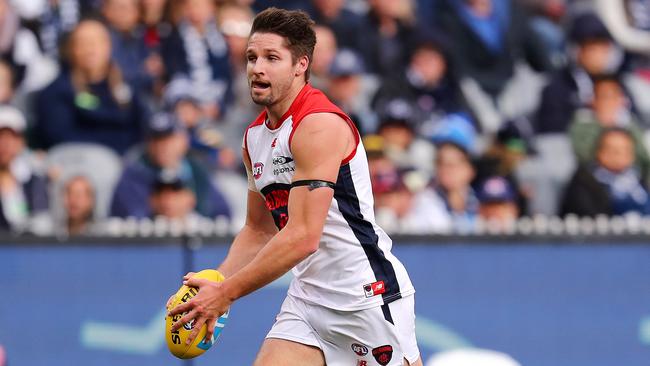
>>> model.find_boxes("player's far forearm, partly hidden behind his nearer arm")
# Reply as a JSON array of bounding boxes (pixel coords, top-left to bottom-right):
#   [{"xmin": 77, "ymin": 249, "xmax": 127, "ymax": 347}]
[{"xmin": 217, "ymin": 225, "xmax": 273, "ymax": 278}]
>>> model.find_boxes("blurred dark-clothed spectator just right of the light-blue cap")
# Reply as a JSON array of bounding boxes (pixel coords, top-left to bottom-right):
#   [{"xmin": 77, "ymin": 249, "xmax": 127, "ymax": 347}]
[{"xmin": 473, "ymin": 118, "xmax": 535, "ymax": 214}]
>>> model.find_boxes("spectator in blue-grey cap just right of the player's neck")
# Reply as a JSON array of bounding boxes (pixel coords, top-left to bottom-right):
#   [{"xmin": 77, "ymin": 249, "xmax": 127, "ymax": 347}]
[{"xmin": 325, "ymin": 49, "xmax": 376, "ymax": 135}]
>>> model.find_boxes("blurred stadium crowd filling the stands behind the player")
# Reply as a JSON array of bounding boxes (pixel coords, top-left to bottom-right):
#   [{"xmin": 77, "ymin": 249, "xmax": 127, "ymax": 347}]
[{"xmin": 0, "ymin": 0, "xmax": 650, "ymax": 237}]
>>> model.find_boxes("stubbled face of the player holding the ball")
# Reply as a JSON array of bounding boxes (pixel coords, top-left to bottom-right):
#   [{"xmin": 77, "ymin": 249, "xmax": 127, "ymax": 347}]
[{"xmin": 246, "ymin": 33, "xmax": 302, "ymax": 107}]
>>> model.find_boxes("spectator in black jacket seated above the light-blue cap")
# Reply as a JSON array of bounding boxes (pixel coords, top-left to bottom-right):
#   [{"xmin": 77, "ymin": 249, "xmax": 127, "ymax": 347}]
[{"xmin": 373, "ymin": 34, "xmax": 467, "ymax": 136}]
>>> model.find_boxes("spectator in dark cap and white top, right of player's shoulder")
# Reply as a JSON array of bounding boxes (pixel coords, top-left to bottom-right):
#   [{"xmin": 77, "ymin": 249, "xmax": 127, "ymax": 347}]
[{"xmin": 377, "ymin": 99, "xmax": 434, "ymax": 177}]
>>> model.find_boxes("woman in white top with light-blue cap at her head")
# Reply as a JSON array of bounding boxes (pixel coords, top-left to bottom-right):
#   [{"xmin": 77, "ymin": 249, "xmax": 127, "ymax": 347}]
[{"xmin": 402, "ymin": 119, "xmax": 478, "ymax": 234}]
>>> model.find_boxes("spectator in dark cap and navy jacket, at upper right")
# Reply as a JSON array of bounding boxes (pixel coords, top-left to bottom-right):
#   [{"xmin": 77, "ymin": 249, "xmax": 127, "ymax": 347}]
[{"xmin": 535, "ymin": 13, "xmax": 650, "ymax": 133}]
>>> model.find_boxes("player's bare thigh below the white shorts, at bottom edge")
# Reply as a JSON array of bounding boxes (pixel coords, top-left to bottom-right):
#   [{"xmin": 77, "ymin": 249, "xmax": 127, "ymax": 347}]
[{"xmin": 254, "ymin": 338, "xmax": 325, "ymax": 366}]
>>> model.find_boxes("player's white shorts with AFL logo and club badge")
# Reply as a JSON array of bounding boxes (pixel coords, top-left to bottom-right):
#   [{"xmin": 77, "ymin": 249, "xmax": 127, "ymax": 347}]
[{"xmin": 266, "ymin": 295, "xmax": 420, "ymax": 366}]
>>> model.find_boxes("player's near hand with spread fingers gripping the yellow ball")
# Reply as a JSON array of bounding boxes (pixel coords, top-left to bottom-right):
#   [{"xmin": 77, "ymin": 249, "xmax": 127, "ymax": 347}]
[{"xmin": 167, "ymin": 278, "xmax": 232, "ymax": 344}]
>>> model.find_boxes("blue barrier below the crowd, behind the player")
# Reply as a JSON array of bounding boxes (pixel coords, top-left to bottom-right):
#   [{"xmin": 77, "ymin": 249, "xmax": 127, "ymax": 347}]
[{"xmin": 0, "ymin": 241, "xmax": 650, "ymax": 366}]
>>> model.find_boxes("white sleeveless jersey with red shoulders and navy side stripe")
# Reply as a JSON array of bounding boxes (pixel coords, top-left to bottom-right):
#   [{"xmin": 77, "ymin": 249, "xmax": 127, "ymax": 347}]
[{"xmin": 244, "ymin": 84, "xmax": 415, "ymax": 311}]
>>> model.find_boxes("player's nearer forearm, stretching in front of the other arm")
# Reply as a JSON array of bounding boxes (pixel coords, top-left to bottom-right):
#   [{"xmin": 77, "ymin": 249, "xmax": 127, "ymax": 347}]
[{"xmin": 219, "ymin": 227, "xmax": 318, "ymax": 301}]
